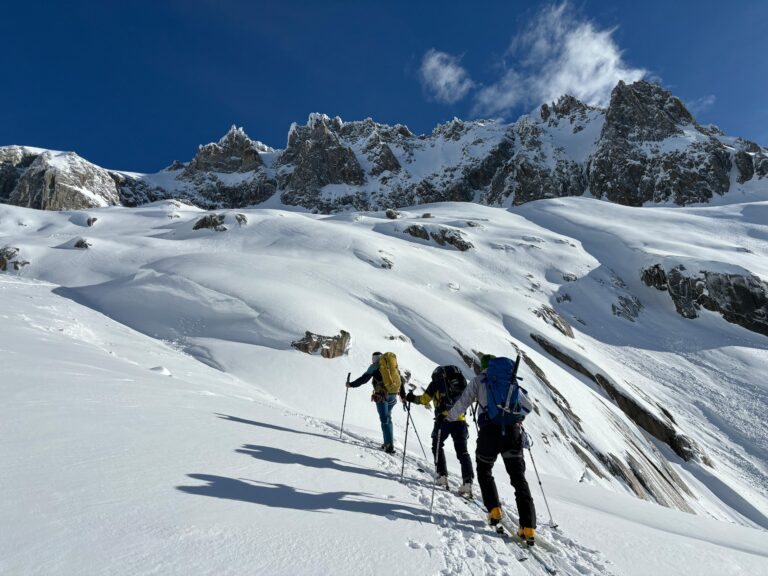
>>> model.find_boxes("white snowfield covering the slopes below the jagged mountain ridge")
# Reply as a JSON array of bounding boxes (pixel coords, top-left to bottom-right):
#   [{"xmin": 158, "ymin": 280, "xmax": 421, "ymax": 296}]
[{"xmin": 0, "ymin": 198, "xmax": 768, "ymax": 576}]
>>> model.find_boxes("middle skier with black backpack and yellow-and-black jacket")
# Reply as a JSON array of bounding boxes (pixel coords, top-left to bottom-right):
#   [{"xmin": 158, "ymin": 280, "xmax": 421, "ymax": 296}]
[{"xmin": 405, "ymin": 366, "xmax": 475, "ymax": 498}]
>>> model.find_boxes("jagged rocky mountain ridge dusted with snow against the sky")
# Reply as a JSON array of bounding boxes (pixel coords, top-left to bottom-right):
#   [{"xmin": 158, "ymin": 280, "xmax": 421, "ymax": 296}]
[{"xmin": 0, "ymin": 81, "xmax": 768, "ymax": 213}]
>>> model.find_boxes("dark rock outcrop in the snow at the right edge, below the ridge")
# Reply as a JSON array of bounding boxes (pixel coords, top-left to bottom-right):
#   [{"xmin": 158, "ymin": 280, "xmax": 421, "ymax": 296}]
[{"xmin": 641, "ymin": 264, "xmax": 768, "ymax": 336}]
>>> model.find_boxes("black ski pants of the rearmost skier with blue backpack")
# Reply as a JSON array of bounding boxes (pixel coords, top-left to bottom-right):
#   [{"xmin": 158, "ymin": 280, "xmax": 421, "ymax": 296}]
[{"xmin": 475, "ymin": 423, "xmax": 536, "ymax": 528}]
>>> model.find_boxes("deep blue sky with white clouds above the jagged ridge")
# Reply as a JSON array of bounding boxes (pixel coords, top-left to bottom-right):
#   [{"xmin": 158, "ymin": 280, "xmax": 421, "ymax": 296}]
[{"xmin": 0, "ymin": 0, "xmax": 768, "ymax": 172}]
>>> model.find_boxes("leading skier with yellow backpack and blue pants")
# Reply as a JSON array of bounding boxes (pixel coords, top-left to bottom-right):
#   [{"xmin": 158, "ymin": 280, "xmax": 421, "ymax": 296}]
[{"xmin": 347, "ymin": 352, "xmax": 405, "ymax": 454}]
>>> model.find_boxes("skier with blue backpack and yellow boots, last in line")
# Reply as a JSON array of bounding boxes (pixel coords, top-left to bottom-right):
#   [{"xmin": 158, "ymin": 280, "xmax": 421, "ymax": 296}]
[{"xmin": 447, "ymin": 355, "xmax": 536, "ymax": 546}]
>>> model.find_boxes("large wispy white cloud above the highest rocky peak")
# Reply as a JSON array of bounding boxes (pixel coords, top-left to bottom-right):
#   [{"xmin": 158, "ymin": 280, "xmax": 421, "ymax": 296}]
[{"xmin": 473, "ymin": 2, "xmax": 647, "ymax": 116}]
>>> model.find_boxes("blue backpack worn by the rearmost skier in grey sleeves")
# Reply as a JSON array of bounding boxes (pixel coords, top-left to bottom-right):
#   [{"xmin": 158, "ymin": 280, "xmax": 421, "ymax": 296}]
[{"xmin": 485, "ymin": 354, "xmax": 533, "ymax": 426}]
